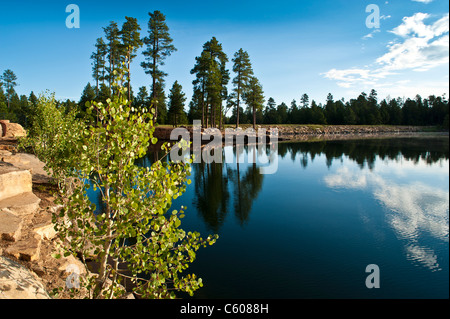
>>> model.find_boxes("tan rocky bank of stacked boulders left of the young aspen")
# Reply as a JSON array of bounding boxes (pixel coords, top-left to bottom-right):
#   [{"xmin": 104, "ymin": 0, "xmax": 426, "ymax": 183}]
[{"xmin": 0, "ymin": 138, "xmax": 83, "ymax": 299}]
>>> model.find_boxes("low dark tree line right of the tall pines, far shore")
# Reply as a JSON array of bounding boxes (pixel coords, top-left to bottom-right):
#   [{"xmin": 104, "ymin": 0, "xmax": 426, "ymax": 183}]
[{"xmin": 227, "ymin": 90, "xmax": 449, "ymax": 129}]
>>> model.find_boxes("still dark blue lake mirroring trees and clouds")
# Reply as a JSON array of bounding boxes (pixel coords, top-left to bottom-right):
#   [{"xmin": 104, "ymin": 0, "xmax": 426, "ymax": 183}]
[{"xmin": 163, "ymin": 135, "xmax": 449, "ymax": 299}]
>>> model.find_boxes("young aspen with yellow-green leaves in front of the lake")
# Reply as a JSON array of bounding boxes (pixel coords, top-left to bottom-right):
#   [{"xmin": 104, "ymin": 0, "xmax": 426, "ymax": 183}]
[{"xmin": 26, "ymin": 66, "xmax": 218, "ymax": 298}]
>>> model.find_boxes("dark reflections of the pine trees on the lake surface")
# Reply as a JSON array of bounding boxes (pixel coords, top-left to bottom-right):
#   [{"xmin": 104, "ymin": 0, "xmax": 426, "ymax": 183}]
[{"xmin": 140, "ymin": 138, "xmax": 449, "ymax": 233}]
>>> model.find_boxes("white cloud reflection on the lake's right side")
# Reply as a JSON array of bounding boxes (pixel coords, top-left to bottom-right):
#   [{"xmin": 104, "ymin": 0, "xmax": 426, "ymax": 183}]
[{"xmin": 324, "ymin": 149, "xmax": 449, "ymax": 271}]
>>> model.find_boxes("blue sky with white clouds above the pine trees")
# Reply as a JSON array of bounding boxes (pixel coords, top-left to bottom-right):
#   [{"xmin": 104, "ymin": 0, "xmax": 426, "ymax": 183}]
[{"xmin": 0, "ymin": 0, "xmax": 449, "ymax": 110}]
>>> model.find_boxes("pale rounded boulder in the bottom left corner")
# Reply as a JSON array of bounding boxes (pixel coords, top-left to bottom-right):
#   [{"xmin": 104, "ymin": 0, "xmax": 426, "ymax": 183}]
[{"xmin": 0, "ymin": 257, "xmax": 51, "ymax": 299}]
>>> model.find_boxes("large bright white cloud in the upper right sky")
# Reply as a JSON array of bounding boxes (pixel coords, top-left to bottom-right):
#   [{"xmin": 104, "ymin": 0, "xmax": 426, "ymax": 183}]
[{"xmin": 322, "ymin": 12, "xmax": 449, "ymax": 94}]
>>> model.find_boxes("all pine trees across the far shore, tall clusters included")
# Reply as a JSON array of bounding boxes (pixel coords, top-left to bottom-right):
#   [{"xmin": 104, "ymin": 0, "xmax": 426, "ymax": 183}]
[{"xmin": 0, "ymin": 11, "xmax": 449, "ymax": 128}]
